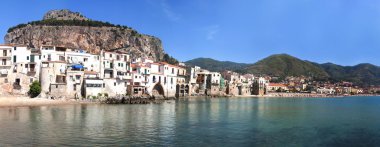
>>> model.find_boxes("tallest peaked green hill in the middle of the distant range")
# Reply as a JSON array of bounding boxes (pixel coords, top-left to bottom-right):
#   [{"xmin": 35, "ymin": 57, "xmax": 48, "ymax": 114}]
[{"xmin": 245, "ymin": 54, "xmax": 328, "ymax": 78}]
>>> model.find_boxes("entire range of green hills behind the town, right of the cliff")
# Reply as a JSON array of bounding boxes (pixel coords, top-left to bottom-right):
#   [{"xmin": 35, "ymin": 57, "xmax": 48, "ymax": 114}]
[{"xmin": 185, "ymin": 54, "xmax": 380, "ymax": 86}]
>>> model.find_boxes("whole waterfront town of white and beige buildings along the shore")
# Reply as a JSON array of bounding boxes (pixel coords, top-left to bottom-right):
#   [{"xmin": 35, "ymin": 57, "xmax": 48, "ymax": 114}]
[{"xmin": 0, "ymin": 45, "xmax": 380, "ymax": 99}]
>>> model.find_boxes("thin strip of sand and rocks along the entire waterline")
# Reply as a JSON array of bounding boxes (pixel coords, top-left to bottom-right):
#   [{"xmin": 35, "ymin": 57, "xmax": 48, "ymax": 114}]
[{"xmin": 0, "ymin": 93, "xmax": 379, "ymax": 108}]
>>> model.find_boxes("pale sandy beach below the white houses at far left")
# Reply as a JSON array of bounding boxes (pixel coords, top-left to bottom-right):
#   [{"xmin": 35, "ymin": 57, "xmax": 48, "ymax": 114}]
[{"xmin": 0, "ymin": 96, "xmax": 81, "ymax": 107}]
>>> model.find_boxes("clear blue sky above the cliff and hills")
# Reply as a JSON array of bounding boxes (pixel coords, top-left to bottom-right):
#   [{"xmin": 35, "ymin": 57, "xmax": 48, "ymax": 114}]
[{"xmin": 0, "ymin": 0, "xmax": 380, "ymax": 65}]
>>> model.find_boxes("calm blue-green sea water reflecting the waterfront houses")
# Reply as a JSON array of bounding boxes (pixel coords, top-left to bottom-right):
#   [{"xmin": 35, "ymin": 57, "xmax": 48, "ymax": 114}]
[{"xmin": 0, "ymin": 97, "xmax": 380, "ymax": 146}]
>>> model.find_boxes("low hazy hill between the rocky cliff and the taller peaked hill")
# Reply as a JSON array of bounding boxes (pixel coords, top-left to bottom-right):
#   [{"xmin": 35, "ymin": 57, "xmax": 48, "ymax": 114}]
[{"xmin": 185, "ymin": 58, "xmax": 249, "ymax": 73}]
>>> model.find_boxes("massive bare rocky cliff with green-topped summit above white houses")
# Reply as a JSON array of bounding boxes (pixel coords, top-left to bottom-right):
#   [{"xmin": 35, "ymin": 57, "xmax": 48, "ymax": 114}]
[{"xmin": 4, "ymin": 10, "xmax": 165, "ymax": 61}]
